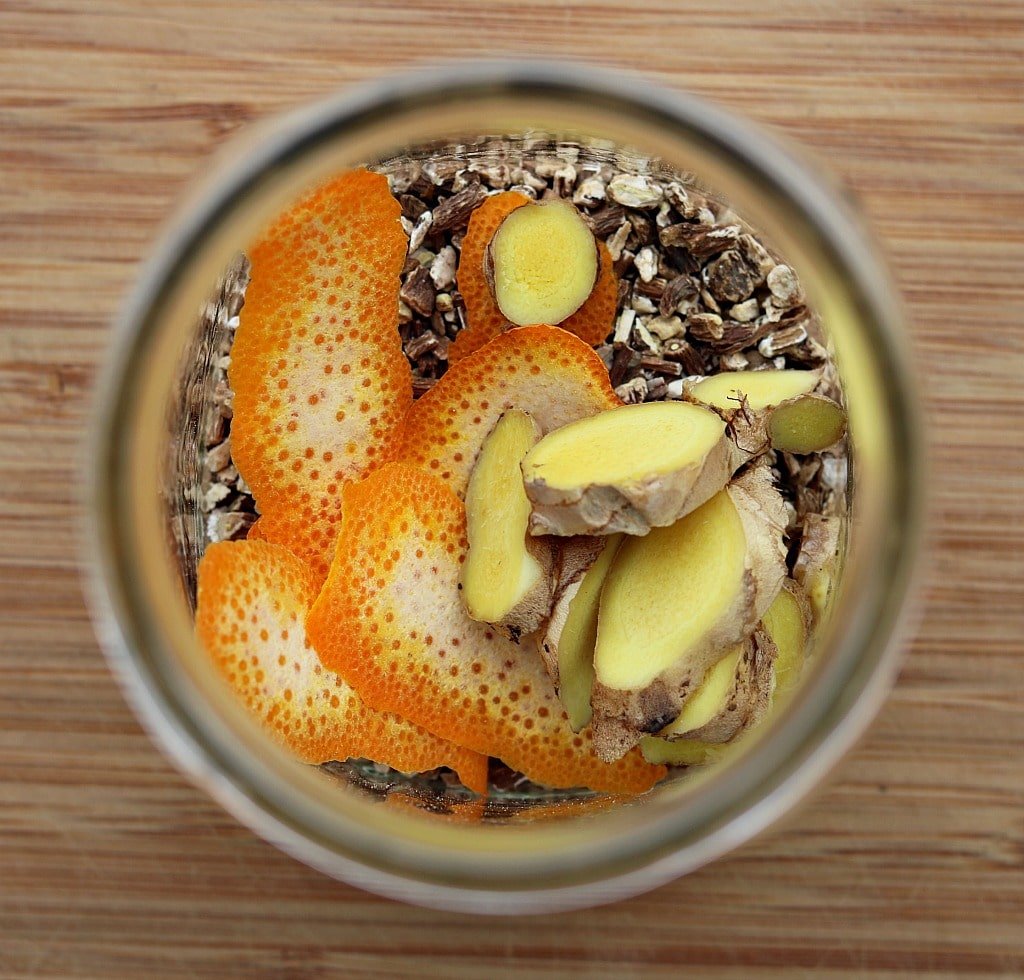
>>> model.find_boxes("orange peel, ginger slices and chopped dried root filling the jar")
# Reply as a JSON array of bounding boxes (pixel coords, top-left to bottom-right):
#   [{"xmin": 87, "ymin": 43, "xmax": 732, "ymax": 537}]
[{"xmin": 197, "ymin": 147, "xmax": 847, "ymax": 796}]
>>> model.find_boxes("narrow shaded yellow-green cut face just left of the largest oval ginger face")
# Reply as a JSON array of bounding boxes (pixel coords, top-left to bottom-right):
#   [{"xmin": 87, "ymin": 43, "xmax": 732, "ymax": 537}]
[{"xmin": 558, "ymin": 535, "xmax": 622, "ymax": 731}]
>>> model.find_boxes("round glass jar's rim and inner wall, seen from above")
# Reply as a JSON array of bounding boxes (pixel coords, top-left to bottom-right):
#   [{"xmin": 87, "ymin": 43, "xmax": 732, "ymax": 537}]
[{"xmin": 88, "ymin": 62, "xmax": 924, "ymax": 912}]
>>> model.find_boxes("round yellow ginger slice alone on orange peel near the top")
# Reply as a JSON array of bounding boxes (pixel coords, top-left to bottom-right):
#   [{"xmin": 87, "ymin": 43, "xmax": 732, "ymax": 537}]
[{"xmin": 484, "ymin": 201, "xmax": 599, "ymax": 327}]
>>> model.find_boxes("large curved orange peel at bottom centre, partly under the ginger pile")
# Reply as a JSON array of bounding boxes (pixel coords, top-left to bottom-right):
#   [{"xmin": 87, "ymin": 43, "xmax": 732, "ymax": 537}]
[{"xmin": 306, "ymin": 463, "xmax": 665, "ymax": 793}]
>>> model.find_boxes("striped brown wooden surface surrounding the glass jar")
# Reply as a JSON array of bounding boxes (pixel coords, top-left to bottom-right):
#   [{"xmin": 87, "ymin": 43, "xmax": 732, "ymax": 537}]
[{"xmin": 0, "ymin": 0, "xmax": 1024, "ymax": 978}]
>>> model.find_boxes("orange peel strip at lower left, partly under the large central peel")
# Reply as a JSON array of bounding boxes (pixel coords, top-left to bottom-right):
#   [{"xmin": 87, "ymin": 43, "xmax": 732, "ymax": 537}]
[{"xmin": 196, "ymin": 541, "xmax": 487, "ymax": 793}]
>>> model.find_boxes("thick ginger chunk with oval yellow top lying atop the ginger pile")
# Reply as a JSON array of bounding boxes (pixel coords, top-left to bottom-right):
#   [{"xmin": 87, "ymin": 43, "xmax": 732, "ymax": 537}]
[{"xmin": 522, "ymin": 401, "xmax": 745, "ymax": 535}]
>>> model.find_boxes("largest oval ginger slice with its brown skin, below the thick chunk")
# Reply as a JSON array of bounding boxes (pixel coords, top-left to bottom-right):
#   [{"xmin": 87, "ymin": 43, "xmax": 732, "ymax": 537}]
[{"xmin": 591, "ymin": 468, "xmax": 786, "ymax": 760}]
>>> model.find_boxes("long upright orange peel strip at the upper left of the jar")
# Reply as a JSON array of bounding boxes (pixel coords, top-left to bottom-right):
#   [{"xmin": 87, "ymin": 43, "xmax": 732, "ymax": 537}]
[{"xmin": 228, "ymin": 170, "xmax": 413, "ymax": 579}]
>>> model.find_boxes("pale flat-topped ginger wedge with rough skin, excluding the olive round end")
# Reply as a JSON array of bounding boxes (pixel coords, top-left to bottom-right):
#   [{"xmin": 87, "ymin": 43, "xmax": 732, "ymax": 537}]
[{"xmin": 683, "ymin": 371, "xmax": 835, "ymax": 458}]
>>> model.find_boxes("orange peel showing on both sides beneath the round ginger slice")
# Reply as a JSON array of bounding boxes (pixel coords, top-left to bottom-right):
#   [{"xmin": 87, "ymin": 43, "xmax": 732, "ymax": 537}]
[{"xmin": 449, "ymin": 190, "xmax": 618, "ymax": 364}]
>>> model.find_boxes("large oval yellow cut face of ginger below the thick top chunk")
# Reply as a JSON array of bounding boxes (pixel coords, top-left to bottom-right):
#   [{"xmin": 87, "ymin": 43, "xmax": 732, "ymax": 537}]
[{"xmin": 594, "ymin": 493, "xmax": 746, "ymax": 690}]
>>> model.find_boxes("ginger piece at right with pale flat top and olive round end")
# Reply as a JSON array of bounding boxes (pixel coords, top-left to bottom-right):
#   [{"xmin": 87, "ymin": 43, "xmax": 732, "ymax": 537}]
[{"xmin": 684, "ymin": 371, "xmax": 846, "ymax": 456}]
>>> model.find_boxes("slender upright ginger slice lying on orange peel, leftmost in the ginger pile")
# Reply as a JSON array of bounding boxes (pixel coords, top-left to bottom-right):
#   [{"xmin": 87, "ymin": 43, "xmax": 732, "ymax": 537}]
[{"xmin": 459, "ymin": 409, "xmax": 554, "ymax": 641}]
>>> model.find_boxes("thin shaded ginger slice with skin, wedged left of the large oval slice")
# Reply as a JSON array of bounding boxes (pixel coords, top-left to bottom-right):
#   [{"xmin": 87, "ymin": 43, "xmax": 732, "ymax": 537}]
[{"xmin": 541, "ymin": 535, "xmax": 623, "ymax": 731}]
